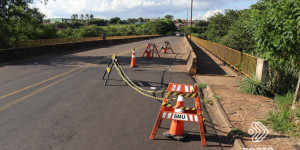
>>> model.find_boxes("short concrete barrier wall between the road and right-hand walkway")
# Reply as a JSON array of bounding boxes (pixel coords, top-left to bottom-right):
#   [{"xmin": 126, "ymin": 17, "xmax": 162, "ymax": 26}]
[{"xmin": 184, "ymin": 37, "xmax": 197, "ymax": 74}]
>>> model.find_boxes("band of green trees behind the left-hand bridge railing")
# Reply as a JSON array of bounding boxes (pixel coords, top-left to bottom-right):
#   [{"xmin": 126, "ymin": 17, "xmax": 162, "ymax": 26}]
[{"xmin": 0, "ymin": 0, "xmax": 177, "ymax": 49}]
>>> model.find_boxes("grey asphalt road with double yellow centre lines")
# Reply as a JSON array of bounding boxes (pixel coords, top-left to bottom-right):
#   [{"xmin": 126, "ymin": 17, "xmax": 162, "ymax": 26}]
[{"xmin": 0, "ymin": 37, "xmax": 220, "ymax": 150}]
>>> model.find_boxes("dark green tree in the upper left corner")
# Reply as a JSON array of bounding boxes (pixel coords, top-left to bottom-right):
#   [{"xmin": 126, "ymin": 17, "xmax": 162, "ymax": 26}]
[{"xmin": 0, "ymin": 0, "xmax": 44, "ymax": 48}]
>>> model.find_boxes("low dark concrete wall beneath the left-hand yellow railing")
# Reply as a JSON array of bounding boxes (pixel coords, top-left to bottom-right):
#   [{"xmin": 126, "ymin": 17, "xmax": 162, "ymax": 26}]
[{"xmin": 0, "ymin": 36, "xmax": 160, "ymax": 63}]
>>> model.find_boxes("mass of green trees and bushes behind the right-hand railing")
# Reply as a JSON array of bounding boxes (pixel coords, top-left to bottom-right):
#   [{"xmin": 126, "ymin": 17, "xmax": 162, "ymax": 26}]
[{"xmin": 186, "ymin": 0, "xmax": 300, "ymax": 95}]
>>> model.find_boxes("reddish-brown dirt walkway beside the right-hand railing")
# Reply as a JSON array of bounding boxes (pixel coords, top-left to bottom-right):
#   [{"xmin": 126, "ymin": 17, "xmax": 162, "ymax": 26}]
[{"xmin": 193, "ymin": 41, "xmax": 300, "ymax": 150}]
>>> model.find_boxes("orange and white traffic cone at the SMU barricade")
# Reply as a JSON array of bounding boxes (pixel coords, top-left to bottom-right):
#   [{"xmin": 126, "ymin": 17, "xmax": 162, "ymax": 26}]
[{"xmin": 164, "ymin": 96, "xmax": 187, "ymax": 140}]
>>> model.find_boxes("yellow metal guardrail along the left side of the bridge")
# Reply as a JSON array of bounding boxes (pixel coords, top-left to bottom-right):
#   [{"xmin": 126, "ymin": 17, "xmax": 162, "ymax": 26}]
[{"xmin": 12, "ymin": 34, "xmax": 159, "ymax": 48}]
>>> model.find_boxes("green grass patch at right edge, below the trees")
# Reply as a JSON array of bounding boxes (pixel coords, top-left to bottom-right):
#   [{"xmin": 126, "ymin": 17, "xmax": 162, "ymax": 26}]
[{"xmin": 267, "ymin": 92, "xmax": 300, "ymax": 136}]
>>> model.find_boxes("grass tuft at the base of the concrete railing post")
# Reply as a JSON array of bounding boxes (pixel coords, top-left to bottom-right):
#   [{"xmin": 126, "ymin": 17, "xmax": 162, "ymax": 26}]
[{"xmin": 239, "ymin": 75, "xmax": 266, "ymax": 95}]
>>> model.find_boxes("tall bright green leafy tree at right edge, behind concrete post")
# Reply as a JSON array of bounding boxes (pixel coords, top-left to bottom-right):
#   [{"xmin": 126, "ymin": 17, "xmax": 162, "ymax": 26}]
[{"xmin": 250, "ymin": 0, "xmax": 300, "ymax": 94}]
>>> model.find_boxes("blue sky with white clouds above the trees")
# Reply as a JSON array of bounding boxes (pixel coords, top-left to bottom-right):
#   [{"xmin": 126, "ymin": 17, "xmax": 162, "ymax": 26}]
[{"xmin": 31, "ymin": 0, "xmax": 257, "ymax": 20}]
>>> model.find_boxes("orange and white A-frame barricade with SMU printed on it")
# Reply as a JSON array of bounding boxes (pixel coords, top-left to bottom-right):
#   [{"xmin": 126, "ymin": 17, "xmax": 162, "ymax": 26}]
[{"xmin": 150, "ymin": 83, "xmax": 206, "ymax": 146}]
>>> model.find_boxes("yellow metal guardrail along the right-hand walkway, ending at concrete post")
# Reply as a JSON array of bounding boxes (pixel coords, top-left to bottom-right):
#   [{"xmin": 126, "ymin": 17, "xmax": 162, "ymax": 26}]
[{"xmin": 192, "ymin": 36, "xmax": 258, "ymax": 77}]
